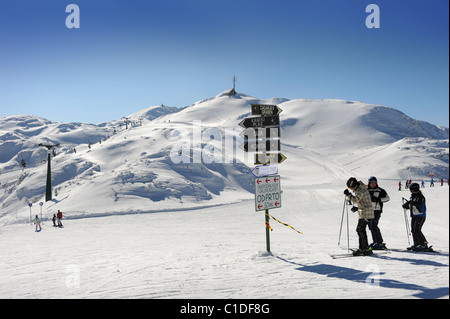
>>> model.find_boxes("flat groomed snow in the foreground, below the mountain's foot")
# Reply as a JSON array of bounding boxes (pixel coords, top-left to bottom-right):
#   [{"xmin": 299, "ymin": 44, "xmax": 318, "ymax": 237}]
[{"xmin": 0, "ymin": 180, "xmax": 449, "ymax": 299}]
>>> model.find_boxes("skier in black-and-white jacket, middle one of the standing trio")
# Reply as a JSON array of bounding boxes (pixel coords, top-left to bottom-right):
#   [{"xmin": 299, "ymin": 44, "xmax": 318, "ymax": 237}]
[{"xmin": 368, "ymin": 176, "xmax": 390, "ymax": 250}]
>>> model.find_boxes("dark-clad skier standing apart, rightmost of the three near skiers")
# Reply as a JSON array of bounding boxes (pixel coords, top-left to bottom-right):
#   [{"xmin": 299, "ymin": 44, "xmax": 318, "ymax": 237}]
[{"xmin": 403, "ymin": 183, "xmax": 430, "ymax": 251}]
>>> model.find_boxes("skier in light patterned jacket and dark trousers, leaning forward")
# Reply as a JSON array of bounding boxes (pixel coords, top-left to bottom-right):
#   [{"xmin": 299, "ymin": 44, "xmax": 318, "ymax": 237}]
[{"xmin": 344, "ymin": 177, "xmax": 375, "ymax": 256}]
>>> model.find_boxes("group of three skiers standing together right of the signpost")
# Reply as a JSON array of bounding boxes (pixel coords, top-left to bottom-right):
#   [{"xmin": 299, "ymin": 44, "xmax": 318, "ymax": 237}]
[{"xmin": 344, "ymin": 176, "xmax": 430, "ymax": 256}]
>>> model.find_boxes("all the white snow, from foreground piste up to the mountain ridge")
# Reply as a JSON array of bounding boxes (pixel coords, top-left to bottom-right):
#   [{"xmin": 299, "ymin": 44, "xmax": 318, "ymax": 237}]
[{"xmin": 0, "ymin": 92, "xmax": 449, "ymax": 298}]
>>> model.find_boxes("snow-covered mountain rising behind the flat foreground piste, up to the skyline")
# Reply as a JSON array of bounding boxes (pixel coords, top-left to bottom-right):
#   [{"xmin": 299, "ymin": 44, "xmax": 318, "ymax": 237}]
[{"xmin": 0, "ymin": 91, "xmax": 449, "ymax": 223}]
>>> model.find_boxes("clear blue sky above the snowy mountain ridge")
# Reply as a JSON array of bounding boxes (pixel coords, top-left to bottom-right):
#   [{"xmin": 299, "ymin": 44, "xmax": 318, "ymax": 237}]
[{"xmin": 0, "ymin": 0, "xmax": 449, "ymax": 127}]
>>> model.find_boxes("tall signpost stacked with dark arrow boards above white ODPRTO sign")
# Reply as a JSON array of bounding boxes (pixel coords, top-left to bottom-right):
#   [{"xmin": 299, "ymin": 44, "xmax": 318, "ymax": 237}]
[{"xmin": 239, "ymin": 104, "xmax": 286, "ymax": 252}]
